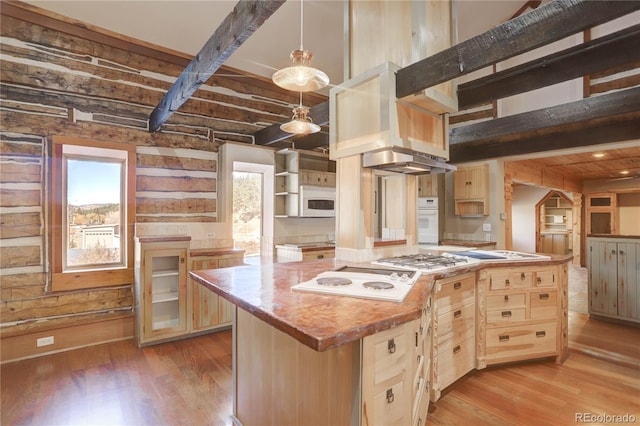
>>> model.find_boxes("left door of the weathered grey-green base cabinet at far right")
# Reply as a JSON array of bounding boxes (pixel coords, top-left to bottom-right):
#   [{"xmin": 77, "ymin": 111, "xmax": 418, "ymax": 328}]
[{"xmin": 589, "ymin": 241, "xmax": 618, "ymax": 315}]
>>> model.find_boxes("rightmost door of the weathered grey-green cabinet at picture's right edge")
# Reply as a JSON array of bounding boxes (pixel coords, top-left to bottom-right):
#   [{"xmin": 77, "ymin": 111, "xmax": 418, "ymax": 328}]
[{"xmin": 617, "ymin": 243, "xmax": 640, "ymax": 319}]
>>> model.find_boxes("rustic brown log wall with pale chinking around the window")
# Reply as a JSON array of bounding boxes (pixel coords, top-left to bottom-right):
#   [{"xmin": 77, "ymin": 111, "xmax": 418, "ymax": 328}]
[{"xmin": 0, "ymin": 2, "xmax": 325, "ymax": 361}]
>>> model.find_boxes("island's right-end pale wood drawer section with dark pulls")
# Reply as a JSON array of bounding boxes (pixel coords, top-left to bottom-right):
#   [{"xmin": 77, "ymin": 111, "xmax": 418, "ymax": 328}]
[{"xmin": 479, "ymin": 266, "xmax": 566, "ymax": 365}]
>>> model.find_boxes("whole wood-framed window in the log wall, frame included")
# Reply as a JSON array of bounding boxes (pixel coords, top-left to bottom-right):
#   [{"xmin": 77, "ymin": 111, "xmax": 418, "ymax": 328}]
[{"xmin": 48, "ymin": 137, "xmax": 135, "ymax": 291}]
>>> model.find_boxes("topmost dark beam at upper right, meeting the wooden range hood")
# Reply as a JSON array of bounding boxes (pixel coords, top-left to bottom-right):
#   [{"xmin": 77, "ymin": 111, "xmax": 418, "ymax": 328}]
[{"xmin": 396, "ymin": 0, "xmax": 640, "ymax": 98}]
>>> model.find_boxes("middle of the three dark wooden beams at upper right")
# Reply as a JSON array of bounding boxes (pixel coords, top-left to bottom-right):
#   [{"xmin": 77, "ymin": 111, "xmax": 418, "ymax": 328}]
[{"xmin": 458, "ymin": 25, "xmax": 640, "ymax": 110}]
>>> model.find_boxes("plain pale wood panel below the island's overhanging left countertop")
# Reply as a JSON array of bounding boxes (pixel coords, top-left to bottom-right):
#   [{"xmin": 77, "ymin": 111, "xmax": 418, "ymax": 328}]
[{"xmin": 234, "ymin": 308, "xmax": 360, "ymax": 426}]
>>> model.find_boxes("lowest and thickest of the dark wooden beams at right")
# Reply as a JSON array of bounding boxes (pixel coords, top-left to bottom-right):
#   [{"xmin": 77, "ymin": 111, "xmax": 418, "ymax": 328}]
[{"xmin": 449, "ymin": 87, "xmax": 640, "ymax": 163}]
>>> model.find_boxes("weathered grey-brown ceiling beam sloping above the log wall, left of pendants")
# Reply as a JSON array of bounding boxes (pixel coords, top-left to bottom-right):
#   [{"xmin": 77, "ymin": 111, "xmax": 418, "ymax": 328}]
[{"xmin": 149, "ymin": 0, "xmax": 286, "ymax": 132}]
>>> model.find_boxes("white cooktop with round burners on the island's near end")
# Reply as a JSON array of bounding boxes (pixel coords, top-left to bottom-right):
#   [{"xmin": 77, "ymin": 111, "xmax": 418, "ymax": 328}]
[{"xmin": 291, "ymin": 266, "xmax": 420, "ymax": 302}]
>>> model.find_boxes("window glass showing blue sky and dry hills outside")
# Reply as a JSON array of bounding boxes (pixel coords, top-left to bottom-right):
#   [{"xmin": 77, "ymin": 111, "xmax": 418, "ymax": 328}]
[{"xmin": 65, "ymin": 157, "xmax": 124, "ymax": 269}]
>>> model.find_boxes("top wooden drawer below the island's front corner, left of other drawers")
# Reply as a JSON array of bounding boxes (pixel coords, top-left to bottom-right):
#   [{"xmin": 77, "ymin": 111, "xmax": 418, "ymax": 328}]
[{"xmin": 373, "ymin": 327, "xmax": 409, "ymax": 386}]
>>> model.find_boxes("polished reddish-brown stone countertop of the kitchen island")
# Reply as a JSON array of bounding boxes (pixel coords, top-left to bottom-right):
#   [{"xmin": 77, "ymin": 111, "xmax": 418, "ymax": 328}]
[{"xmin": 189, "ymin": 255, "xmax": 573, "ymax": 351}]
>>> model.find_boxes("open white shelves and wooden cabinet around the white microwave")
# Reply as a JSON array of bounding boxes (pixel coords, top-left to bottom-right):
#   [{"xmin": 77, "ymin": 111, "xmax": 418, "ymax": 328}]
[{"xmin": 275, "ymin": 148, "xmax": 336, "ymax": 217}]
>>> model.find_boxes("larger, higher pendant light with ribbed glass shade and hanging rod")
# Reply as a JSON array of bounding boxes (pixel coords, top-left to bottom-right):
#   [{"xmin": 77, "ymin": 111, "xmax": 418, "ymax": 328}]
[{"xmin": 272, "ymin": 0, "xmax": 329, "ymax": 92}]
